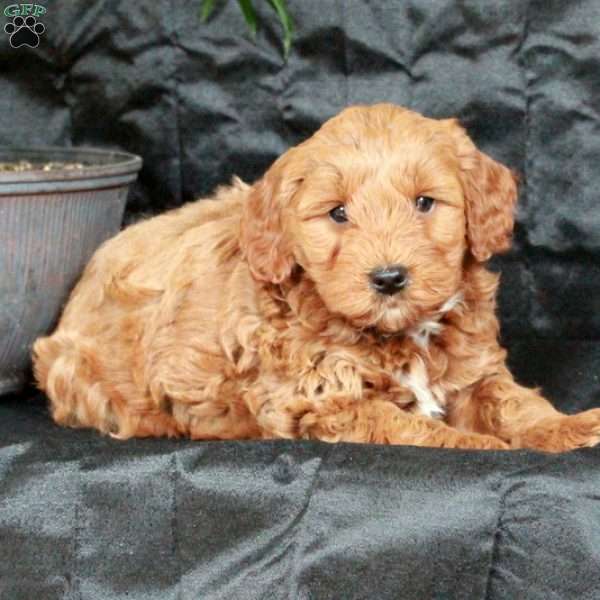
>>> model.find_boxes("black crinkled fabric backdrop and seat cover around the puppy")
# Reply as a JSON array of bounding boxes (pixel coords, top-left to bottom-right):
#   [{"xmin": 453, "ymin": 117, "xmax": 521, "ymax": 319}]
[{"xmin": 0, "ymin": 0, "xmax": 600, "ymax": 600}]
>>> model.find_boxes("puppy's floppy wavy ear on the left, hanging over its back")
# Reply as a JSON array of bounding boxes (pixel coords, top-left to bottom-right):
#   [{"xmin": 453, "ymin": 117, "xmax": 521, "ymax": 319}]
[{"xmin": 240, "ymin": 151, "xmax": 302, "ymax": 283}]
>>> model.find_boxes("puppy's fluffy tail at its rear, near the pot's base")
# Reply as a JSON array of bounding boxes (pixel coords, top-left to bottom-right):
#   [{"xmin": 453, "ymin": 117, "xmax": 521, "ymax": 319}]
[{"xmin": 33, "ymin": 332, "xmax": 118, "ymax": 433}]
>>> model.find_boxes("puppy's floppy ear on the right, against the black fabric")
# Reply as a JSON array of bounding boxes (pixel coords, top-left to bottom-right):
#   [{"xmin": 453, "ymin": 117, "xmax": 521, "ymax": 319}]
[{"xmin": 446, "ymin": 119, "xmax": 517, "ymax": 262}]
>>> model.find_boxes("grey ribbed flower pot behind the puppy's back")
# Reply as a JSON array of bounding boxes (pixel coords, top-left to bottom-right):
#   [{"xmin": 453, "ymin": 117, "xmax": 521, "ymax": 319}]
[{"xmin": 0, "ymin": 147, "xmax": 142, "ymax": 395}]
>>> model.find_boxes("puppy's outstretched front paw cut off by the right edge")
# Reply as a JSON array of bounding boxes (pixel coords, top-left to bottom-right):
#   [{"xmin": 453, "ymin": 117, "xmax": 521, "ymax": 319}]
[{"xmin": 513, "ymin": 408, "xmax": 600, "ymax": 452}]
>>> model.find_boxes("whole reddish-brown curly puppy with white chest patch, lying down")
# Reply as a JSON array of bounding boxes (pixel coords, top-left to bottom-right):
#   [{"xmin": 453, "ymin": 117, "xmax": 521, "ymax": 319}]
[{"xmin": 34, "ymin": 104, "xmax": 600, "ymax": 451}]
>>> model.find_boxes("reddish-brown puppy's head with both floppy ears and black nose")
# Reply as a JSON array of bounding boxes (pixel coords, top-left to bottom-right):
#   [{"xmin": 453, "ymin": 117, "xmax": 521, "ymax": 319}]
[{"xmin": 242, "ymin": 105, "xmax": 516, "ymax": 332}]
